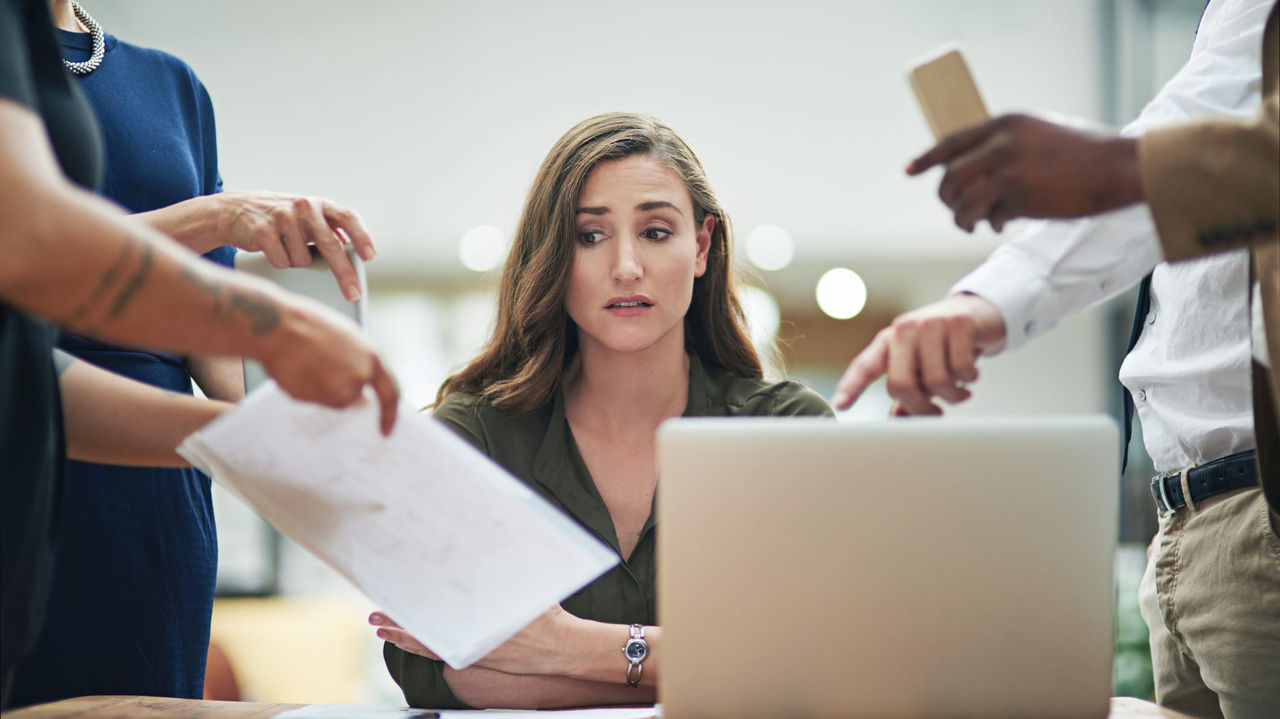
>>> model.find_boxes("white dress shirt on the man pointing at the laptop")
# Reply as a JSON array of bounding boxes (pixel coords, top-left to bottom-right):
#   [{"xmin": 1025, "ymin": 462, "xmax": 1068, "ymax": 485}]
[{"xmin": 951, "ymin": 0, "xmax": 1271, "ymax": 472}]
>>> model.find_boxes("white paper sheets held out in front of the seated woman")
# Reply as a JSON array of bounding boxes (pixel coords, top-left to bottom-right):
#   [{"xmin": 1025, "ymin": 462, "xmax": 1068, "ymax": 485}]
[{"xmin": 178, "ymin": 383, "xmax": 617, "ymax": 669}]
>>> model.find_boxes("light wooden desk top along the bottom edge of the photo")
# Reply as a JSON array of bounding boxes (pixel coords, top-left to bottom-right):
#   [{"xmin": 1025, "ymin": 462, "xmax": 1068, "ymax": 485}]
[{"xmin": 3, "ymin": 696, "xmax": 1192, "ymax": 719}]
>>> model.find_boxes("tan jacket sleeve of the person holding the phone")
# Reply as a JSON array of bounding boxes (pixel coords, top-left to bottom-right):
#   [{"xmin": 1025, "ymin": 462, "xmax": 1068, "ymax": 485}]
[{"xmin": 1138, "ymin": 5, "xmax": 1280, "ymax": 261}]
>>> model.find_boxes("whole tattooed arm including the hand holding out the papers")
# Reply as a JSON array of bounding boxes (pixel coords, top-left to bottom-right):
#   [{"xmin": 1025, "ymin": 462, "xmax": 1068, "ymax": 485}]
[{"xmin": 0, "ymin": 99, "xmax": 399, "ymax": 431}]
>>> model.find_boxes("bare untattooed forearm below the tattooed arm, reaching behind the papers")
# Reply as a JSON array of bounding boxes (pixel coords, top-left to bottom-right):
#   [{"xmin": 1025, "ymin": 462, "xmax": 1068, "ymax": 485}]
[{"xmin": 58, "ymin": 350, "xmax": 232, "ymax": 467}]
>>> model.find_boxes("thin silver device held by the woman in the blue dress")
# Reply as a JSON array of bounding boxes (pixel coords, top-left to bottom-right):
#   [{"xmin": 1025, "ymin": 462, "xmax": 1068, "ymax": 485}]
[{"xmin": 236, "ymin": 243, "xmax": 369, "ymax": 393}]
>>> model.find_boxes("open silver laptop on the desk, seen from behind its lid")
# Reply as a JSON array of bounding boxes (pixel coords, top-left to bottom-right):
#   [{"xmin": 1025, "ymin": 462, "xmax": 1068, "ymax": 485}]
[{"xmin": 658, "ymin": 416, "xmax": 1120, "ymax": 719}]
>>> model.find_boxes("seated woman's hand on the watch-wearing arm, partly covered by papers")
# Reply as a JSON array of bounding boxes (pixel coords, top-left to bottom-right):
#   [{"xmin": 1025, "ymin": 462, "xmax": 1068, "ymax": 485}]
[{"xmin": 369, "ymin": 604, "xmax": 581, "ymax": 674}]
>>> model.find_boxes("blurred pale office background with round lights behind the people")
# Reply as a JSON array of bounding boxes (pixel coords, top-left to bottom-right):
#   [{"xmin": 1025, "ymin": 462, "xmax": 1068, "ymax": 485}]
[{"xmin": 92, "ymin": 0, "xmax": 1204, "ymax": 702}]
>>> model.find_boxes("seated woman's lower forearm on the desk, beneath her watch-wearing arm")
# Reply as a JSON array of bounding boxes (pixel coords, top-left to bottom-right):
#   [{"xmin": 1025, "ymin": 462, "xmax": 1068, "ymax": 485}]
[{"xmin": 444, "ymin": 665, "xmax": 657, "ymax": 709}]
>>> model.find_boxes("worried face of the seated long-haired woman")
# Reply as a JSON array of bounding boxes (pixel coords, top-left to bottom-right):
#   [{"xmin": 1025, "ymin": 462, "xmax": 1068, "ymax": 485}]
[{"xmin": 564, "ymin": 155, "xmax": 716, "ymax": 352}]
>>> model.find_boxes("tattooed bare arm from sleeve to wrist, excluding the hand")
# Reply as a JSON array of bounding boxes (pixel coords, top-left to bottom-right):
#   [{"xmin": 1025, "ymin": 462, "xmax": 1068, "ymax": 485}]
[{"xmin": 0, "ymin": 100, "xmax": 294, "ymax": 356}]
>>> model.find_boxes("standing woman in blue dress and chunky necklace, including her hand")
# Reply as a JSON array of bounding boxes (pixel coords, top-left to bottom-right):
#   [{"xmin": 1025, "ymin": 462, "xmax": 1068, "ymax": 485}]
[{"xmin": 12, "ymin": 0, "xmax": 384, "ymax": 706}]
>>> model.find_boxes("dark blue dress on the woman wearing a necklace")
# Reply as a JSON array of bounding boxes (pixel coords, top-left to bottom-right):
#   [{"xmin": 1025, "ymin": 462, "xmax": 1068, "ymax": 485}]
[{"xmin": 13, "ymin": 31, "xmax": 234, "ymax": 705}]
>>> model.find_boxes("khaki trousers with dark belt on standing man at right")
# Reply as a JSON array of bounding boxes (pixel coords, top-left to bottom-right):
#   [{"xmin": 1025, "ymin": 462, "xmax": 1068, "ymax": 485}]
[{"xmin": 1138, "ymin": 481, "xmax": 1280, "ymax": 719}]
